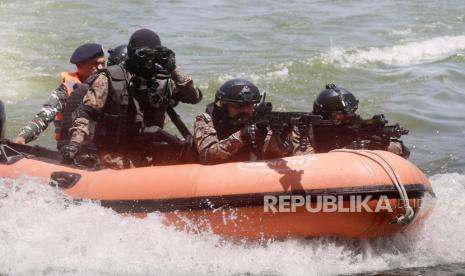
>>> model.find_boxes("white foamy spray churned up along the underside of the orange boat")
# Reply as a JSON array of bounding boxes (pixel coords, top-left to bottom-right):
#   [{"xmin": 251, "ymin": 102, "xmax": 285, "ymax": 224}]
[{"xmin": 0, "ymin": 174, "xmax": 465, "ymax": 275}]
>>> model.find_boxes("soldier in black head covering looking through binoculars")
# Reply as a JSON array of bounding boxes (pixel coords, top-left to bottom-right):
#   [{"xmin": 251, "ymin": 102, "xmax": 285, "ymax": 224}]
[{"xmin": 61, "ymin": 29, "xmax": 202, "ymax": 169}]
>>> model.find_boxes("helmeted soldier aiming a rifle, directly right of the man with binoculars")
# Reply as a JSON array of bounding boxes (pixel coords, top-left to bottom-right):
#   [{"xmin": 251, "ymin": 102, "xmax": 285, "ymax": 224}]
[{"xmin": 194, "ymin": 79, "xmax": 292, "ymax": 164}]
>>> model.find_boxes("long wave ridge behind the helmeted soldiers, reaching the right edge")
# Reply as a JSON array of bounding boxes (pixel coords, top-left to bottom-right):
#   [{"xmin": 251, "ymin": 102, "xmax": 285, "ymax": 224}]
[{"xmin": 206, "ymin": 35, "xmax": 465, "ymax": 90}]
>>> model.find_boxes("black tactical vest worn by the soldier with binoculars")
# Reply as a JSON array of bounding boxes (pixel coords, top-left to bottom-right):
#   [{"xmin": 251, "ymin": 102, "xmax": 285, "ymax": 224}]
[{"xmin": 95, "ymin": 65, "xmax": 169, "ymax": 148}]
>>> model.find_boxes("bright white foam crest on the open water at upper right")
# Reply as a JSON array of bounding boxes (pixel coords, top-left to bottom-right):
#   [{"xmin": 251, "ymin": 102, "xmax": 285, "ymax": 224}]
[{"xmin": 318, "ymin": 35, "xmax": 465, "ymax": 67}]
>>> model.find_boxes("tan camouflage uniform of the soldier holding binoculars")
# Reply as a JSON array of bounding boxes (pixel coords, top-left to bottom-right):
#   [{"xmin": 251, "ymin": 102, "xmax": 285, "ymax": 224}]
[{"xmin": 69, "ymin": 68, "xmax": 202, "ymax": 169}]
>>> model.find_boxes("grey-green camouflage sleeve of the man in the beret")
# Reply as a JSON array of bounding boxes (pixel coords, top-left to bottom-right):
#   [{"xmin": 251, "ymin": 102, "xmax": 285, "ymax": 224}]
[{"xmin": 19, "ymin": 84, "xmax": 68, "ymax": 143}]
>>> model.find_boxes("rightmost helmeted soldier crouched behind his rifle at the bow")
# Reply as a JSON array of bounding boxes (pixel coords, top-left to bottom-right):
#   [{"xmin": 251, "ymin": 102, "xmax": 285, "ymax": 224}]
[{"xmin": 292, "ymin": 84, "xmax": 410, "ymax": 158}]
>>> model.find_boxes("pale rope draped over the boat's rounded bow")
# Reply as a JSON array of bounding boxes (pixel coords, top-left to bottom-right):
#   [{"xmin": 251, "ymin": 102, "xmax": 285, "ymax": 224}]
[{"xmin": 331, "ymin": 149, "xmax": 415, "ymax": 224}]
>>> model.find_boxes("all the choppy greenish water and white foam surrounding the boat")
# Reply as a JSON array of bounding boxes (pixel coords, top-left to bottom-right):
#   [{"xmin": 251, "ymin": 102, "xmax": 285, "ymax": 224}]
[{"xmin": 0, "ymin": 0, "xmax": 465, "ymax": 275}]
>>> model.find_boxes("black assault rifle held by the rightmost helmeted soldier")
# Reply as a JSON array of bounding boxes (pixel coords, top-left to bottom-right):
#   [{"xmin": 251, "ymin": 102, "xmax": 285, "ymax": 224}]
[{"xmin": 310, "ymin": 114, "xmax": 409, "ymax": 152}]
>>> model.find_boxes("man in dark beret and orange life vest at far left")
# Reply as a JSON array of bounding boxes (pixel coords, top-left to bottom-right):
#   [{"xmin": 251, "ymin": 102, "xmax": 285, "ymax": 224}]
[{"xmin": 11, "ymin": 43, "xmax": 105, "ymax": 147}]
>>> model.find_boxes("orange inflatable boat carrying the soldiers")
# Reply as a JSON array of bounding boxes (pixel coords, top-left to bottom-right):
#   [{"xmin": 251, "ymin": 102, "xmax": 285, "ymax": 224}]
[{"xmin": 0, "ymin": 142, "xmax": 434, "ymax": 239}]
